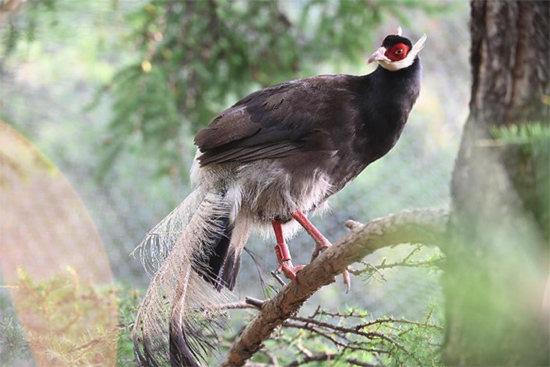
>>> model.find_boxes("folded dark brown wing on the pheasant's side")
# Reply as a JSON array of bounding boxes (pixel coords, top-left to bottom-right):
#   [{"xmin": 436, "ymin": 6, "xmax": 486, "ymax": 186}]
[{"xmin": 195, "ymin": 76, "xmax": 349, "ymax": 166}]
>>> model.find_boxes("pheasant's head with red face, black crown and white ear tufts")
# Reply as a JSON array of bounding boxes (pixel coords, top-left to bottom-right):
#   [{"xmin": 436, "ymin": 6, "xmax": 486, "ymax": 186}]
[{"xmin": 368, "ymin": 27, "xmax": 427, "ymax": 71}]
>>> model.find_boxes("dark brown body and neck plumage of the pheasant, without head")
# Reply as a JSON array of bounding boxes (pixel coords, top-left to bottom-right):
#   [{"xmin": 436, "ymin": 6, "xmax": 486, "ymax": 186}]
[{"xmin": 195, "ymin": 59, "xmax": 421, "ymax": 219}]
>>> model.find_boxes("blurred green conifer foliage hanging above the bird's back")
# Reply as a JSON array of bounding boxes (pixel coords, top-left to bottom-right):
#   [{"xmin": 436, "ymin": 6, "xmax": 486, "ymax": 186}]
[{"xmin": 85, "ymin": 0, "xmax": 443, "ymax": 177}]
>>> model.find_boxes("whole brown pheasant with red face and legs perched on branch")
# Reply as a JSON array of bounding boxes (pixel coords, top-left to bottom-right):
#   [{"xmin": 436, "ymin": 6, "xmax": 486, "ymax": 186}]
[{"xmin": 133, "ymin": 27, "xmax": 427, "ymax": 367}]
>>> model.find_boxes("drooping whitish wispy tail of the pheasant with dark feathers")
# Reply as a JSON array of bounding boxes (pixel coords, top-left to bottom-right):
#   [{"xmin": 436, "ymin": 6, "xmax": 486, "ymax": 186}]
[{"xmin": 133, "ymin": 185, "xmax": 250, "ymax": 367}]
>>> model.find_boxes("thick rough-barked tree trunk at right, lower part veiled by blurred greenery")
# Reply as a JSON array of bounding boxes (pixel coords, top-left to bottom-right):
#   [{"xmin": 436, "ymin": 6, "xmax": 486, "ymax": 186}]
[{"xmin": 443, "ymin": 0, "xmax": 550, "ymax": 366}]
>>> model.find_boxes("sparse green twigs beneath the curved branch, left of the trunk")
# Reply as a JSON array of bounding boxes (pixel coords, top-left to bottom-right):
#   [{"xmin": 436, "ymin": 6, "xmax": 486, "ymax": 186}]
[{"xmin": 243, "ymin": 306, "xmax": 443, "ymax": 367}]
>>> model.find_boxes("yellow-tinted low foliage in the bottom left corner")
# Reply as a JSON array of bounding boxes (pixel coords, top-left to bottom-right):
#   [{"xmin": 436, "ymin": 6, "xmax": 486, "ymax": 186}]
[{"xmin": 0, "ymin": 268, "xmax": 139, "ymax": 366}]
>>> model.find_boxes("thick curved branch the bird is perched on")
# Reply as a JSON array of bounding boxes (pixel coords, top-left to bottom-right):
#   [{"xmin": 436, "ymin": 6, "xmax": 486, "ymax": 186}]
[{"xmin": 223, "ymin": 209, "xmax": 447, "ymax": 367}]
